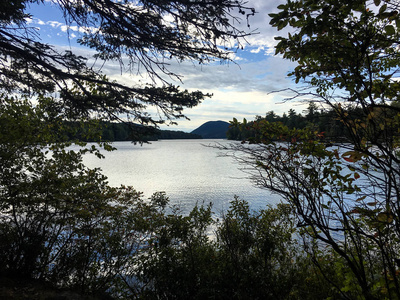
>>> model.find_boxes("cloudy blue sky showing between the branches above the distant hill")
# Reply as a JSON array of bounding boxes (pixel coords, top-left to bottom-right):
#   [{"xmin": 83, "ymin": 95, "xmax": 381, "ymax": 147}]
[{"xmin": 24, "ymin": 0, "xmax": 307, "ymax": 132}]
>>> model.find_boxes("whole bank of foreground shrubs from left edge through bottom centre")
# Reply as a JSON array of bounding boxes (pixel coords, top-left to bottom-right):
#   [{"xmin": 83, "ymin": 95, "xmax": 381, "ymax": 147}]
[{"xmin": 0, "ymin": 97, "xmax": 340, "ymax": 299}]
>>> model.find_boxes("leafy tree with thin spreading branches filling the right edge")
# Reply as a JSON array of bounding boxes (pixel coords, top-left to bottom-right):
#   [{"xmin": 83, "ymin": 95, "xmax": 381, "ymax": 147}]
[{"xmin": 223, "ymin": 0, "xmax": 400, "ymax": 299}]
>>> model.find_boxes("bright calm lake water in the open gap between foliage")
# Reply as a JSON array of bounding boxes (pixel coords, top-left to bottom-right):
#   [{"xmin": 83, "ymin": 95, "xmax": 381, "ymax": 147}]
[{"xmin": 84, "ymin": 140, "xmax": 279, "ymax": 214}]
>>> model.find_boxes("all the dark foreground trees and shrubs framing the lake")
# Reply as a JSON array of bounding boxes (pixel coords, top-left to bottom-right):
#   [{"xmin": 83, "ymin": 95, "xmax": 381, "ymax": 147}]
[{"xmin": 0, "ymin": 0, "xmax": 400, "ymax": 299}]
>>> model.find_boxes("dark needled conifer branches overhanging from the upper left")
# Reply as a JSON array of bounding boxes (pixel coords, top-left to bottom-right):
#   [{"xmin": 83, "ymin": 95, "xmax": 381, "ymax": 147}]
[{"xmin": 0, "ymin": 0, "xmax": 255, "ymax": 137}]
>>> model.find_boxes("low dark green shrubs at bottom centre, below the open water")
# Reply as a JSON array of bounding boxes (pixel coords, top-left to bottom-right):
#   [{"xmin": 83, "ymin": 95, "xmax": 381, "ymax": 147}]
[{"xmin": 136, "ymin": 199, "xmax": 335, "ymax": 299}]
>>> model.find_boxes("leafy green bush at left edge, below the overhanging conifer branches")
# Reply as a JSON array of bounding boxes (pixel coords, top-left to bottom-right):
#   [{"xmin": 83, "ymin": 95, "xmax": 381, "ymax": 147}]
[{"xmin": 0, "ymin": 98, "xmax": 150, "ymax": 293}]
